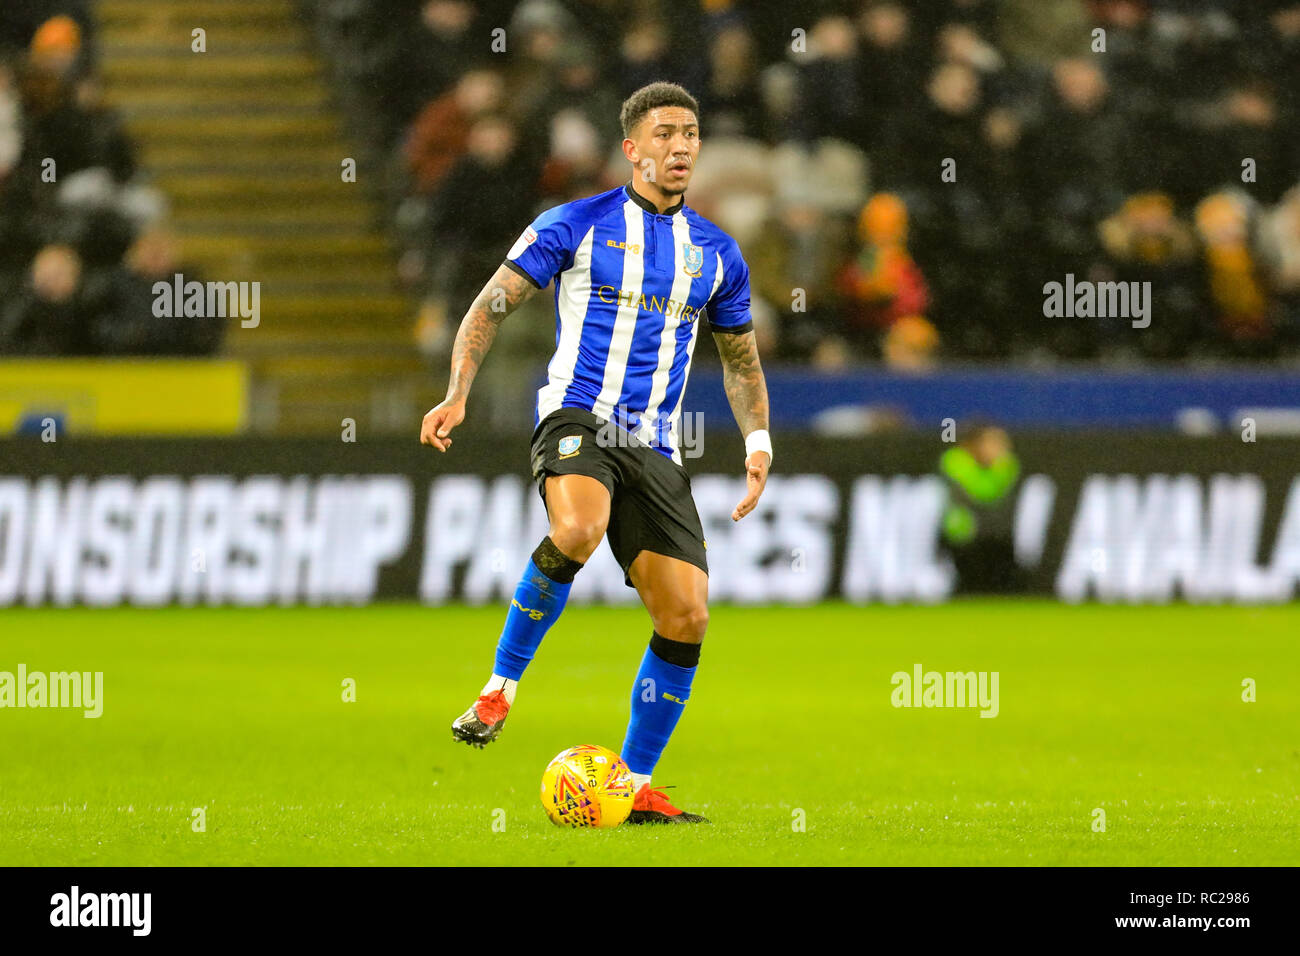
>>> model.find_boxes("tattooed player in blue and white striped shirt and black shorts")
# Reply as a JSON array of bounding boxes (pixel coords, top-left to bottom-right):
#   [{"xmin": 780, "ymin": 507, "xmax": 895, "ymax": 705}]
[{"xmin": 420, "ymin": 82, "xmax": 772, "ymax": 823}]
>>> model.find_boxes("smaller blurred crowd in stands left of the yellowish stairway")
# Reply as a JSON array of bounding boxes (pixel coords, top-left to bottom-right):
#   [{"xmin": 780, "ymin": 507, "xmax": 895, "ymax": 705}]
[{"xmin": 0, "ymin": 0, "xmax": 224, "ymax": 355}]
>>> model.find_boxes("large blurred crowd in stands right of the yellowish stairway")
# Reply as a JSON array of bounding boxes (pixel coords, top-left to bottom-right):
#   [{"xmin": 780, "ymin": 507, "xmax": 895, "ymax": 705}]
[{"xmin": 308, "ymin": 0, "xmax": 1300, "ymax": 367}]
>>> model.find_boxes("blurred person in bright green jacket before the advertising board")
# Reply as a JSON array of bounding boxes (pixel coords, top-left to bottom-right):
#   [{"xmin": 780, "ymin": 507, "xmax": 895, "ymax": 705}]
[{"xmin": 939, "ymin": 423, "xmax": 1022, "ymax": 593}]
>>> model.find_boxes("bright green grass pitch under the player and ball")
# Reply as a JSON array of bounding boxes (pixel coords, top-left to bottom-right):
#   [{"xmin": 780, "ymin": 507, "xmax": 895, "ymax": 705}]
[{"xmin": 0, "ymin": 601, "xmax": 1300, "ymax": 866}]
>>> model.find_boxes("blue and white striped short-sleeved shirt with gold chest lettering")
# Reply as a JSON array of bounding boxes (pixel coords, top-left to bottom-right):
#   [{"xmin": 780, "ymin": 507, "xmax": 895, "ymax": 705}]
[{"xmin": 506, "ymin": 183, "xmax": 754, "ymax": 464}]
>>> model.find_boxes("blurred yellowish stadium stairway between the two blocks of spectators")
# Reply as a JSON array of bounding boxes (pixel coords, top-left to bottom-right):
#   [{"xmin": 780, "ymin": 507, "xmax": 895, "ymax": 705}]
[{"xmin": 95, "ymin": 0, "xmax": 430, "ymax": 434}]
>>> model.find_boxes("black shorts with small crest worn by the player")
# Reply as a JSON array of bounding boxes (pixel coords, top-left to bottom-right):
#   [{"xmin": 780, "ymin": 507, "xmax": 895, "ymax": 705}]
[{"xmin": 533, "ymin": 408, "xmax": 709, "ymax": 588}]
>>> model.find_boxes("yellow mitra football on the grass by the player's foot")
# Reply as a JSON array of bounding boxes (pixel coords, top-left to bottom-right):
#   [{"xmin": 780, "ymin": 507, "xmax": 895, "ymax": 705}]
[{"xmin": 542, "ymin": 744, "xmax": 636, "ymax": 827}]
